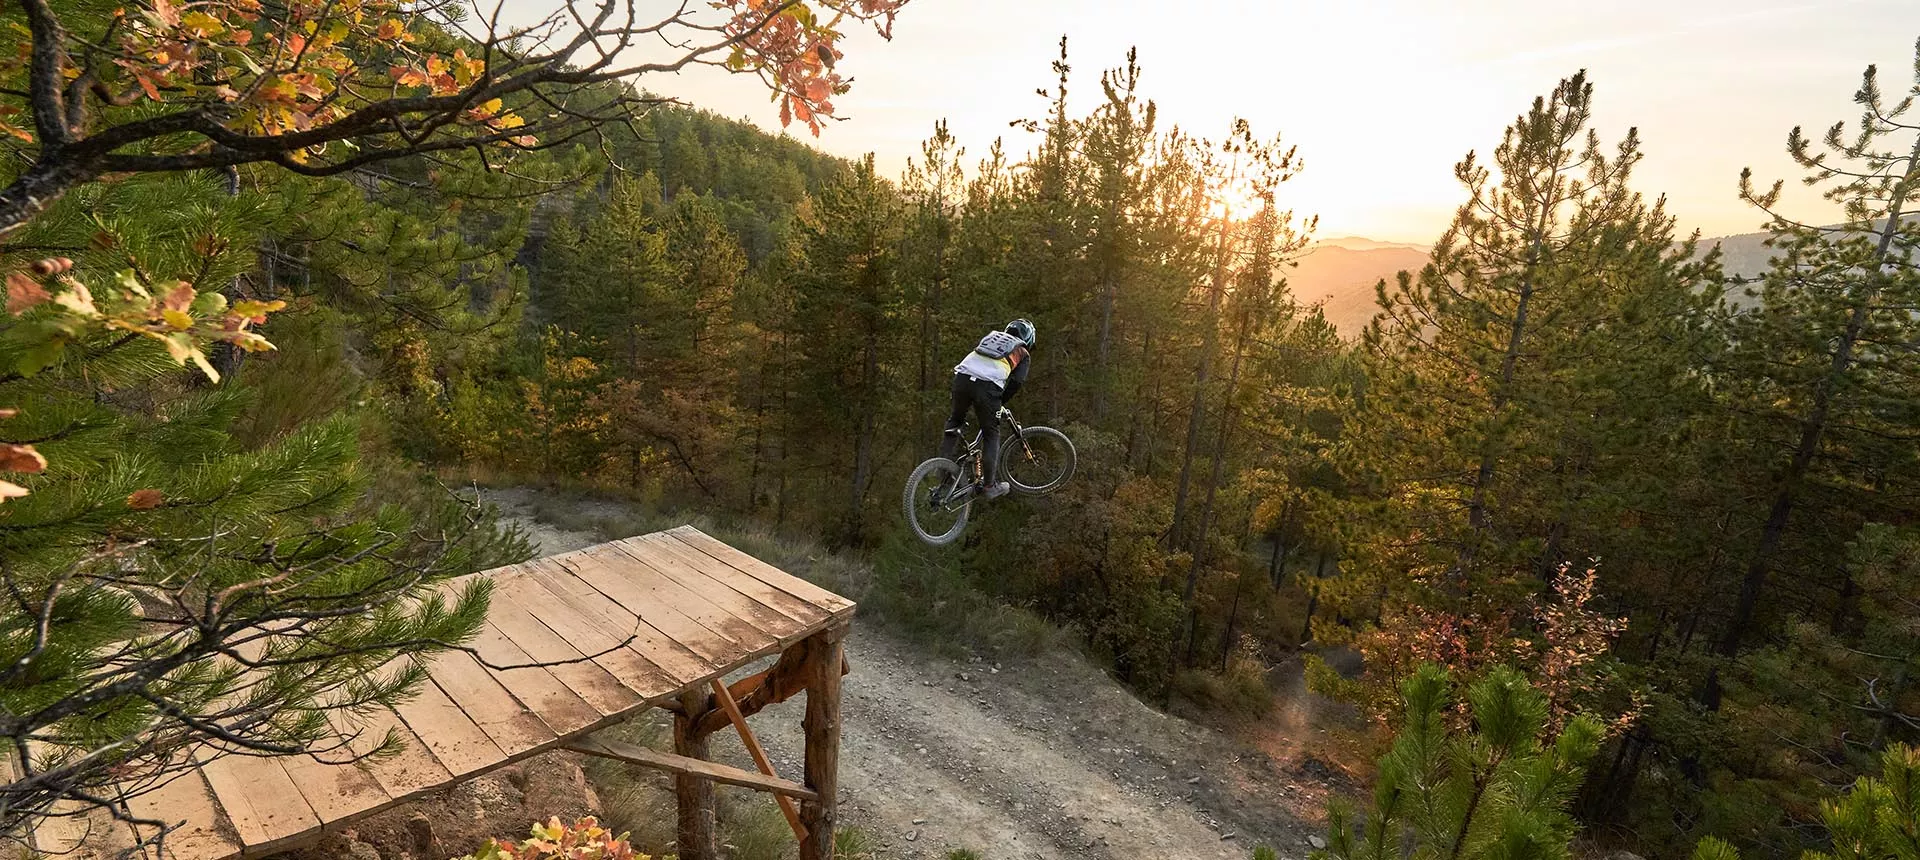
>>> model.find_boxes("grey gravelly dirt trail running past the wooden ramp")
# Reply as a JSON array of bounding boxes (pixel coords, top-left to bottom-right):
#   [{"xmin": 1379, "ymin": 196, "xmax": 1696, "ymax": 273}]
[{"xmin": 493, "ymin": 493, "xmax": 1325, "ymax": 860}]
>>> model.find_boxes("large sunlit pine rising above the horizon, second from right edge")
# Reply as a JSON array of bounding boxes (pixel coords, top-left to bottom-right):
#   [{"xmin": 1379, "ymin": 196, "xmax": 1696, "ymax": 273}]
[{"xmin": 1329, "ymin": 75, "xmax": 1715, "ymax": 694}]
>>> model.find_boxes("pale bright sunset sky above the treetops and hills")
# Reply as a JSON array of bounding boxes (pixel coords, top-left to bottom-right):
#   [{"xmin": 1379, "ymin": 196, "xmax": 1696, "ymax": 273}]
[{"xmin": 509, "ymin": 0, "xmax": 1920, "ymax": 244}]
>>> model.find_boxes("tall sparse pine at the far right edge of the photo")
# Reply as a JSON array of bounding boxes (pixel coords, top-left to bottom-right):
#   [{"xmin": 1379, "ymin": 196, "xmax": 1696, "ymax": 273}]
[{"xmin": 1703, "ymin": 48, "xmax": 1920, "ymax": 708}]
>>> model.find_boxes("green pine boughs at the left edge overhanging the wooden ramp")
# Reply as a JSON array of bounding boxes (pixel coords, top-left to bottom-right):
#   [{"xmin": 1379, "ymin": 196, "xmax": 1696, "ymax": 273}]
[{"xmin": 0, "ymin": 169, "xmax": 526, "ymax": 831}]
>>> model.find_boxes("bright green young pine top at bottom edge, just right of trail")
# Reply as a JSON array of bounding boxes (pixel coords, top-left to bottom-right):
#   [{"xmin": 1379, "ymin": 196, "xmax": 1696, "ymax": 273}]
[{"xmin": 1309, "ymin": 664, "xmax": 1601, "ymax": 860}]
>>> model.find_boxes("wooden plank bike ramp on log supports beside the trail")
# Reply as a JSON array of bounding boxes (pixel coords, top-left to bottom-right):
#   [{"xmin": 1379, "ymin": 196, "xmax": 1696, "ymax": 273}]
[{"xmin": 35, "ymin": 526, "xmax": 854, "ymax": 860}]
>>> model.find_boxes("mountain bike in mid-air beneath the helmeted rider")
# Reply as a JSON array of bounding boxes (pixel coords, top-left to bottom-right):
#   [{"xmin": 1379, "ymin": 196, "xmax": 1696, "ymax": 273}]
[{"xmin": 900, "ymin": 407, "xmax": 1077, "ymax": 547}]
